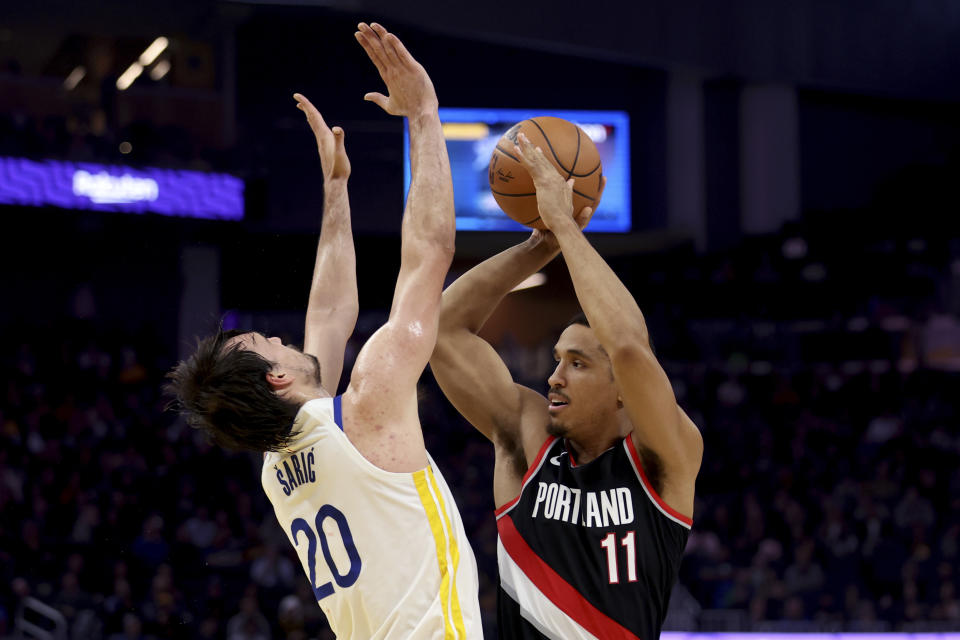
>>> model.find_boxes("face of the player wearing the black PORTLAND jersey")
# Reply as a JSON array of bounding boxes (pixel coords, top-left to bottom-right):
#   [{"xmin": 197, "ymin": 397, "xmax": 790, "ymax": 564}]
[{"xmin": 547, "ymin": 324, "xmax": 618, "ymax": 436}]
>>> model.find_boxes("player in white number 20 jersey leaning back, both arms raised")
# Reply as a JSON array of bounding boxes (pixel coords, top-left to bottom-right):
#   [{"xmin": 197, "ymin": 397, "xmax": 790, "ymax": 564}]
[{"xmin": 171, "ymin": 23, "xmax": 482, "ymax": 639}]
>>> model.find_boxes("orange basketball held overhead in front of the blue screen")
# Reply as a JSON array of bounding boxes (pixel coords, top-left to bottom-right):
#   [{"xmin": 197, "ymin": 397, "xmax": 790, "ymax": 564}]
[{"xmin": 488, "ymin": 116, "xmax": 603, "ymax": 229}]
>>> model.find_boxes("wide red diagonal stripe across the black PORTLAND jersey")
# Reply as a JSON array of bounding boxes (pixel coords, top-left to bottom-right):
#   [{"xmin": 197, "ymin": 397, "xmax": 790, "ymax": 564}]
[{"xmin": 497, "ymin": 518, "xmax": 639, "ymax": 640}]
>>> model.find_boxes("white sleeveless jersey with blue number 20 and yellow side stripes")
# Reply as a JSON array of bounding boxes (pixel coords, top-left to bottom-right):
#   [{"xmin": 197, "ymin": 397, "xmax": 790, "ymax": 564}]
[{"xmin": 261, "ymin": 396, "xmax": 483, "ymax": 640}]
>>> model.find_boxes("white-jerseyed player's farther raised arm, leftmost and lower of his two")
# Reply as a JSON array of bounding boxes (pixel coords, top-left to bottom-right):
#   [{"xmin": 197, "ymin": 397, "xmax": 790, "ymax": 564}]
[{"xmin": 293, "ymin": 93, "xmax": 359, "ymax": 393}]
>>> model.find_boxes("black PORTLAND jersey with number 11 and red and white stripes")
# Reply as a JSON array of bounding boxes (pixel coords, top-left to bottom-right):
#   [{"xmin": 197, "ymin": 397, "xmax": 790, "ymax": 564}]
[{"xmin": 497, "ymin": 436, "xmax": 691, "ymax": 640}]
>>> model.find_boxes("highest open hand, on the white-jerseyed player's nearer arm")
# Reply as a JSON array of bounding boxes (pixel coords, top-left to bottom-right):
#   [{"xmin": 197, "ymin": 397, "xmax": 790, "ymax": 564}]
[{"xmin": 354, "ymin": 22, "xmax": 438, "ymax": 118}]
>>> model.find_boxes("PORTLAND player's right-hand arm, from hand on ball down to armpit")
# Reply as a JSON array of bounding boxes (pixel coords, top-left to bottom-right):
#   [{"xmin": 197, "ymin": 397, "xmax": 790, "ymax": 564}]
[{"xmin": 515, "ymin": 135, "xmax": 703, "ymax": 515}]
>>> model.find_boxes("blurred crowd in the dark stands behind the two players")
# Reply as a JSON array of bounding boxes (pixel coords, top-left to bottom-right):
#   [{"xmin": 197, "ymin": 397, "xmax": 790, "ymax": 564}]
[{"xmin": 0, "ymin": 228, "xmax": 960, "ymax": 640}]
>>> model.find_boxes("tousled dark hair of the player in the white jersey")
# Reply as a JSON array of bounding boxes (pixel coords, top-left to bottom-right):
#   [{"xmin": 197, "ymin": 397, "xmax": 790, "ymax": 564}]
[{"xmin": 165, "ymin": 328, "xmax": 300, "ymax": 452}]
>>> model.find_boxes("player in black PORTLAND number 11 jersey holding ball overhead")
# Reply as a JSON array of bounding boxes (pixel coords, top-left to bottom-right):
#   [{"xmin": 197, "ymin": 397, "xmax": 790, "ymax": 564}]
[{"xmin": 430, "ymin": 136, "xmax": 703, "ymax": 640}]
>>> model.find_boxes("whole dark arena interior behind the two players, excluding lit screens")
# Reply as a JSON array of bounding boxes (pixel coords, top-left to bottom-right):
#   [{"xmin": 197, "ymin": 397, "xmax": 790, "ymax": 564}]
[{"xmin": 0, "ymin": 0, "xmax": 960, "ymax": 639}]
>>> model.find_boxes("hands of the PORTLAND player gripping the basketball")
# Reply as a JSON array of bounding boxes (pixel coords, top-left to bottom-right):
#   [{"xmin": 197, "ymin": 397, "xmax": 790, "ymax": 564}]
[{"xmin": 514, "ymin": 133, "xmax": 607, "ymax": 235}]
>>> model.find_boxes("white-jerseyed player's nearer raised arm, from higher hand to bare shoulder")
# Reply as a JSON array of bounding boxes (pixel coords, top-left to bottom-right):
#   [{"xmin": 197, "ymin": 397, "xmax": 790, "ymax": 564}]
[{"xmin": 343, "ymin": 23, "xmax": 455, "ymax": 471}]
